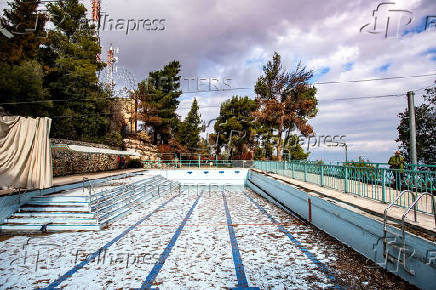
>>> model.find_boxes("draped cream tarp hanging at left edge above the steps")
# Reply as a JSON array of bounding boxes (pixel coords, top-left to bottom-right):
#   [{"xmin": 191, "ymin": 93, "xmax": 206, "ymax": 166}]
[{"xmin": 0, "ymin": 116, "xmax": 53, "ymax": 189}]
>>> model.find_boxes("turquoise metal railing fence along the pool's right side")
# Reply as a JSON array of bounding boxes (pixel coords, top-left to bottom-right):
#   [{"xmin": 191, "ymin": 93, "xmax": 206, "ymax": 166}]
[{"xmin": 254, "ymin": 161, "xmax": 436, "ymax": 213}]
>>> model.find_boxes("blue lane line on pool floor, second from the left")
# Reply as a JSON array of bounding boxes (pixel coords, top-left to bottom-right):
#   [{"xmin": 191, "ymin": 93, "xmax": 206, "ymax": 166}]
[{"xmin": 141, "ymin": 192, "xmax": 203, "ymax": 289}]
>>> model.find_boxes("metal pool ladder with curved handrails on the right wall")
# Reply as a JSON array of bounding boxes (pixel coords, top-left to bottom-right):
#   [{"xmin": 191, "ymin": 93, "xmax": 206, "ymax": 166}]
[{"xmin": 383, "ymin": 190, "xmax": 436, "ymax": 275}]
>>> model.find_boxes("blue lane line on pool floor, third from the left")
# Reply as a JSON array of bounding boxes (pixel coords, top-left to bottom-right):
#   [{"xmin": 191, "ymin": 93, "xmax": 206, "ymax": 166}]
[{"xmin": 221, "ymin": 191, "xmax": 249, "ymax": 289}]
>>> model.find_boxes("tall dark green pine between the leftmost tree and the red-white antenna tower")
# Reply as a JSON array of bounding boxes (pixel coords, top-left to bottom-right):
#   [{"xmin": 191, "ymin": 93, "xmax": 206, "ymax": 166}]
[{"xmin": 41, "ymin": 0, "xmax": 111, "ymax": 142}]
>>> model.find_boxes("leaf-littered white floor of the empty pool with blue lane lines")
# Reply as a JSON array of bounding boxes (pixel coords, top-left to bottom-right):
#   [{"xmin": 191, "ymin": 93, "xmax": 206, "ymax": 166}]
[{"xmin": 0, "ymin": 177, "xmax": 411, "ymax": 289}]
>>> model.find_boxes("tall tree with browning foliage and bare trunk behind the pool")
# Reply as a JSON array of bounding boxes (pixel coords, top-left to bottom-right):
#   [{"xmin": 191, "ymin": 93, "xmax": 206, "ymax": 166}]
[{"xmin": 254, "ymin": 52, "xmax": 318, "ymax": 160}]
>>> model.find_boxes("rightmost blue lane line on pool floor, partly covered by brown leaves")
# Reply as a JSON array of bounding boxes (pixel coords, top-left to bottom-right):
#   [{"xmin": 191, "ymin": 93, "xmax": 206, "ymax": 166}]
[{"xmin": 243, "ymin": 192, "xmax": 342, "ymax": 289}]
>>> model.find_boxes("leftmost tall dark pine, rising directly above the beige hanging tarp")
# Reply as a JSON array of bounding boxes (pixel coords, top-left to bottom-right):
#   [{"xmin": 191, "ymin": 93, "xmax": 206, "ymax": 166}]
[{"xmin": 0, "ymin": 0, "xmax": 52, "ymax": 117}]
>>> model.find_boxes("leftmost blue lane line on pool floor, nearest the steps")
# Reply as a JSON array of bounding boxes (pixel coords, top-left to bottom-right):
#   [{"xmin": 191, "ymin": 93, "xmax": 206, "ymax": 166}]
[{"xmin": 38, "ymin": 194, "xmax": 180, "ymax": 289}]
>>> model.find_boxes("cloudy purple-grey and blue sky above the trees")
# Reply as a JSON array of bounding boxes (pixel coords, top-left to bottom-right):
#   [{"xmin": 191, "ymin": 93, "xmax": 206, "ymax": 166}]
[{"xmin": 4, "ymin": 0, "xmax": 436, "ymax": 162}]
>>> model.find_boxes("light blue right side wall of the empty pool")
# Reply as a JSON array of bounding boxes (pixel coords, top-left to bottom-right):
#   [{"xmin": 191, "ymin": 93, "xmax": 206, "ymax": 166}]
[{"xmin": 246, "ymin": 171, "xmax": 436, "ymax": 289}]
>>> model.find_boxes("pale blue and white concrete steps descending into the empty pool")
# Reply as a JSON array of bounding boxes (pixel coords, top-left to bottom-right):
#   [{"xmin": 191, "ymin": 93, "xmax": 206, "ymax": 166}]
[{"xmin": 0, "ymin": 177, "xmax": 170, "ymax": 232}]
